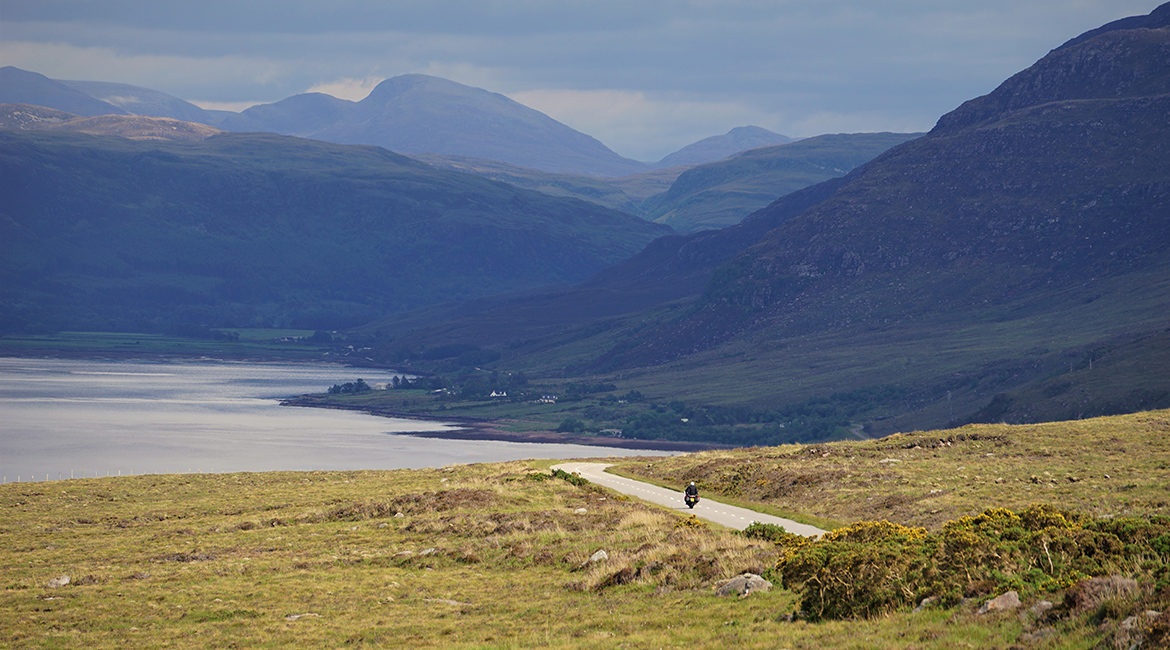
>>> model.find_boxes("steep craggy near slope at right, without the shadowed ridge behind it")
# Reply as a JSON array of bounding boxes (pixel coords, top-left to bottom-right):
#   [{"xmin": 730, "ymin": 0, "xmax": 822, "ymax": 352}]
[{"xmin": 582, "ymin": 8, "xmax": 1170, "ymax": 430}]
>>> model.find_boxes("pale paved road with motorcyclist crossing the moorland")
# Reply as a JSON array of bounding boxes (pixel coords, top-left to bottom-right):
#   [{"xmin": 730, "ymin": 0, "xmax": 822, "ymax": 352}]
[{"xmin": 552, "ymin": 463, "xmax": 825, "ymax": 537}]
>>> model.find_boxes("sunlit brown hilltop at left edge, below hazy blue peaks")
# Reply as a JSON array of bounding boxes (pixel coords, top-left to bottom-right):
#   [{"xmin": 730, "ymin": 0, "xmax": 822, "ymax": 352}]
[{"xmin": 0, "ymin": 104, "xmax": 222, "ymax": 141}]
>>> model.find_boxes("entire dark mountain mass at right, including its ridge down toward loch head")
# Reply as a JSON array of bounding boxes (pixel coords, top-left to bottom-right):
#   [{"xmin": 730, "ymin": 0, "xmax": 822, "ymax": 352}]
[{"xmin": 351, "ymin": 6, "xmax": 1170, "ymax": 435}]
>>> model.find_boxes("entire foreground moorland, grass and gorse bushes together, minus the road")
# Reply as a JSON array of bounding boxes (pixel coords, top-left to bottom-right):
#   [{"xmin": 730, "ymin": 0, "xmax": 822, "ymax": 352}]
[{"xmin": 0, "ymin": 412, "xmax": 1170, "ymax": 650}]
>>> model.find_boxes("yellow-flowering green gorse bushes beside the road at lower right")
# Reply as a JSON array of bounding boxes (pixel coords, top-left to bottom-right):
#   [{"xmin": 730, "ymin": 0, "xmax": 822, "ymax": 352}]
[{"xmin": 776, "ymin": 505, "xmax": 1170, "ymax": 618}]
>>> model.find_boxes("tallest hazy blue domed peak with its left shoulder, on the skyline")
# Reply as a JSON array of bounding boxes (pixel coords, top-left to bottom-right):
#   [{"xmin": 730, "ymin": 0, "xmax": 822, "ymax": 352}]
[{"xmin": 222, "ymin": 75, "xmax": 648, "ymax": 177}]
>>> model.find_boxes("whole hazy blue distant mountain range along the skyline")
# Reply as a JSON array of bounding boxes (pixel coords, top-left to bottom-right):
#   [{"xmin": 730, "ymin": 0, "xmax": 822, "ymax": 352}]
[{"xmin": 0, "ymin": 65, "xmax": 814, "ymax": 177}]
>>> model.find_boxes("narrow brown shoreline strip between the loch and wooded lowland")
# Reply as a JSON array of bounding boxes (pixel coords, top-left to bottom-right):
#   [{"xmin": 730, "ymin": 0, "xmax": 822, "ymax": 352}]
[{"xmin": 281, "ymin": 395, "xmax": 729, "ymax": 452}]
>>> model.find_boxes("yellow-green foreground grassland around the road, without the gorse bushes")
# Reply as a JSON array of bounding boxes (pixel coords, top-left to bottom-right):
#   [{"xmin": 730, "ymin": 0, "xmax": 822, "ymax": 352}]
[{"xmin": 0, "ymin": 412, "xmax": 1170, "ymax": 649}]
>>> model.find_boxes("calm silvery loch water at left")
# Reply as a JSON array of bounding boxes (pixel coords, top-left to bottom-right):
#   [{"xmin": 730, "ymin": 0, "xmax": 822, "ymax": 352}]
[{"xmin": 0, "ymin": 358, "xmax": 669, "ymax": 482}]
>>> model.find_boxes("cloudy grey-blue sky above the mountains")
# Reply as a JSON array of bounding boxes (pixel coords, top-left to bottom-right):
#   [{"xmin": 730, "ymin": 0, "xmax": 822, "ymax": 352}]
[{"xmin": 0, "ymin": 0, "xmax": 1162, "ymax": 161}]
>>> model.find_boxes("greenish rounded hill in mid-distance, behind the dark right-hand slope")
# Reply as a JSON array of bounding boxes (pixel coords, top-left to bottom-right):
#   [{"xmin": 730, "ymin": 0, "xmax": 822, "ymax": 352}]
[{"xmin": 641, "ymin": 133, "xmax": 918, "ymax": 233}]
